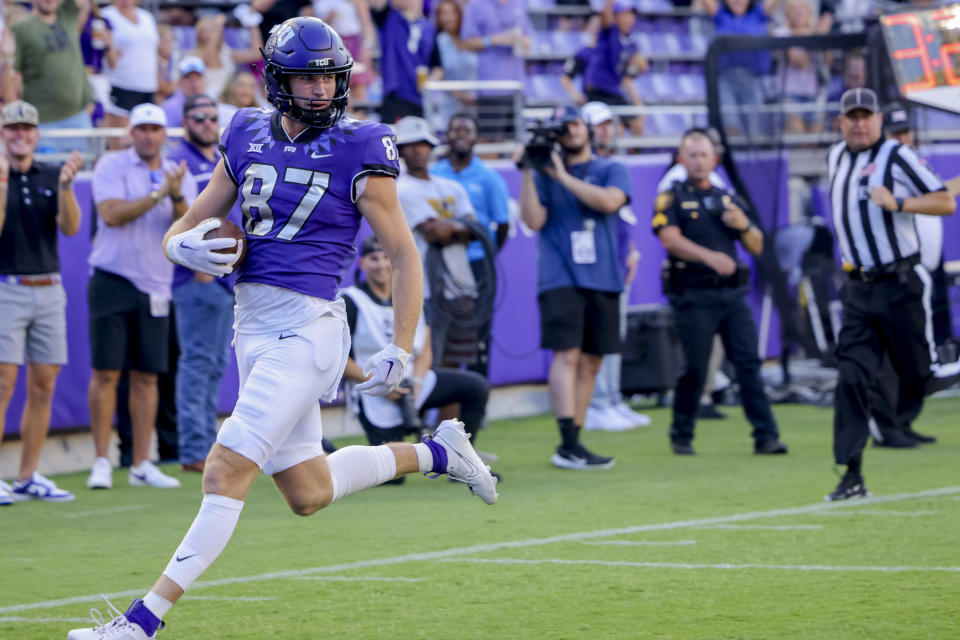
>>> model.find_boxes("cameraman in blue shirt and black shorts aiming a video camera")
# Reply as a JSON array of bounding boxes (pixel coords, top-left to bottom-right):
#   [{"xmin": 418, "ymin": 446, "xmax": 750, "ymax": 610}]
[{"xmin": 515, "ymin": 106, "xmax": 630, "ymax": 470}]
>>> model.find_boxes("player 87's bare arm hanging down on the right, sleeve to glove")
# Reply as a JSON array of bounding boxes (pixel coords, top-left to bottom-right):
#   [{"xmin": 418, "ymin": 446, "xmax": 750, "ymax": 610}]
[{"xmin": 357, "ymin": 175, "xmax": 423, "ymax": 353}]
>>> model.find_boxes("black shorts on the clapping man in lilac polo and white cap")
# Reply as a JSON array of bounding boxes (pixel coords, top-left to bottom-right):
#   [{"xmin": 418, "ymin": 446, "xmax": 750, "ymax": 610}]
[{"xmin": 87, "ymin": 269, "xmax": 170, "ymax": 373}]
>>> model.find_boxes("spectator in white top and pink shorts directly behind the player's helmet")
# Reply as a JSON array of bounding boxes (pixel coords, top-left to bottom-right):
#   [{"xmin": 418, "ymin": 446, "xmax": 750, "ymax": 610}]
[{"xmin": 313, "ymin": 0, "xmax": 376, "ymax": 102}]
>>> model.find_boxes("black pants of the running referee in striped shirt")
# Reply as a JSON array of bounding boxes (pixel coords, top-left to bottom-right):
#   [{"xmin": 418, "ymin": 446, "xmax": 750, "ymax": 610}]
[{"xmin": 833, "ymin": 266, "xmax": 931, "ymax": 465}]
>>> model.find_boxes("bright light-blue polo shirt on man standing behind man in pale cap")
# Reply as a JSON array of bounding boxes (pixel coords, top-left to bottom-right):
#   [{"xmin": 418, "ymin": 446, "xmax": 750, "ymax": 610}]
[{"xmin": 430, "ymin": 156, "xmax": 510, "ymax": 262}]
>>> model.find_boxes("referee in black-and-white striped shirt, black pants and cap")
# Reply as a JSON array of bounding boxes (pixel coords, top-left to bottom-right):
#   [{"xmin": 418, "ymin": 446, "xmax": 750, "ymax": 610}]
[{"xmin": 826, "ymin": 89, "xmax": 956, "ymax": 500}]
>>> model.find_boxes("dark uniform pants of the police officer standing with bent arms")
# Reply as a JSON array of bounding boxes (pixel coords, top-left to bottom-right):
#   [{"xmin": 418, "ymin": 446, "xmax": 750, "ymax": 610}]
[{"xmin": 670, "ymin": 287, "xmax": 779, "ymax": 444}]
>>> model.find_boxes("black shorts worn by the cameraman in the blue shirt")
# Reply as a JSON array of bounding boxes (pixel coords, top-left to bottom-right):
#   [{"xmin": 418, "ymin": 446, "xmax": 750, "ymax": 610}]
[{"xmin": 537, "ymin": 287, "xmax": 622, "ymax": 356}]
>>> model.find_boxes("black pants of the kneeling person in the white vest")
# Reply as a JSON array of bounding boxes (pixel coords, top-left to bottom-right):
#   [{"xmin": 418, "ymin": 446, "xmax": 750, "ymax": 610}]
[{"xmin": 358, "ymin": 369, "xmax": 490, "ymax": 445}]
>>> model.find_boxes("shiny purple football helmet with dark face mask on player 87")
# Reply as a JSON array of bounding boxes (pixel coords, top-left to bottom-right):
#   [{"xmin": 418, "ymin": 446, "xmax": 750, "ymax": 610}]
[{"xmin": 261, "ymin": 17, "xmax": 353, "ymax": 129}]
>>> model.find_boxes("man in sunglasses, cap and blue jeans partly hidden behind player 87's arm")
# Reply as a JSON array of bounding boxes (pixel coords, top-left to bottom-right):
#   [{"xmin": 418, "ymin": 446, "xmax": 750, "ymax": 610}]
[{"xmin": 167, "ymin": 95, "xmax": 240, "ymax": 472}]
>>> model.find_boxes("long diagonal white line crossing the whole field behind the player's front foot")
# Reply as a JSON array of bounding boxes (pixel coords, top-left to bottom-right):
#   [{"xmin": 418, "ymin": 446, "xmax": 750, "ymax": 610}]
[{"xmin": 0, "ymin": 486, "xmax": 960, "ymax": 614}]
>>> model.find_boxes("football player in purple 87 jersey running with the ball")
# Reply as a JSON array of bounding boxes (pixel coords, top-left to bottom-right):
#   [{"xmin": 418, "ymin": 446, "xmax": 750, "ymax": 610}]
[{"xmin": 67, "ymin": 17, "xmax": 497, "ymax": 640}]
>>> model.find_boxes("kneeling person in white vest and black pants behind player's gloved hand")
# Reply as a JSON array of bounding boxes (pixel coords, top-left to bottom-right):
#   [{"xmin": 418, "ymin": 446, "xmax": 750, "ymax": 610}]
[{"xmin": 340, "ymin": 236, "xmax": 500, "ymax": 484}]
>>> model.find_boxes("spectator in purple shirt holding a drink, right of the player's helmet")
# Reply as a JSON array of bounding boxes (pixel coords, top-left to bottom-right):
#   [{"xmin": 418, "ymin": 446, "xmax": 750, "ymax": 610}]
[{"xmin": 370, "ymin": 0, "xmax": 435, "ymax": 124}]
